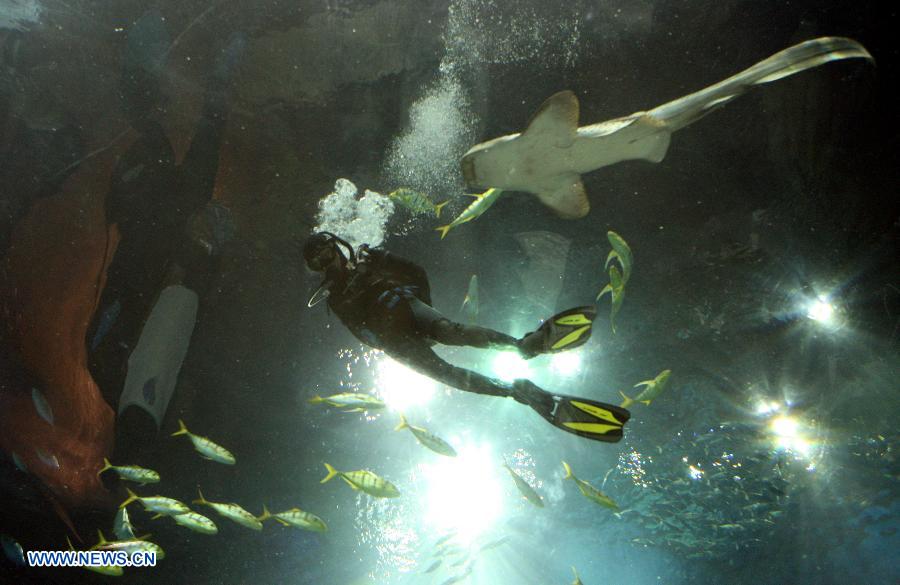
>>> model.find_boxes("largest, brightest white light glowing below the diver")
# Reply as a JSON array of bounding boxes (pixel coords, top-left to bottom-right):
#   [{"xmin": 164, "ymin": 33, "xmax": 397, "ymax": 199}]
[{"xmin": 423, "ymin": 445, "xmax": 503, "ymax": 543}]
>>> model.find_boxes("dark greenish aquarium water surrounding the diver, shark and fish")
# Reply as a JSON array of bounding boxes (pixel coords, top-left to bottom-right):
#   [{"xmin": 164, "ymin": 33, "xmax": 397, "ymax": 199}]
[{"xmin": 0, "ymin": 0, "xmax": 900, "ymax": 585}]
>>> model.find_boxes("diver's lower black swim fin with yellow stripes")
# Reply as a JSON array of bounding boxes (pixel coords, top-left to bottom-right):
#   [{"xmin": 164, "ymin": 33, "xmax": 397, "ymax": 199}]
[{"xmin": 512, "ymin": 380, "xmax": 631, "ymax": 443}]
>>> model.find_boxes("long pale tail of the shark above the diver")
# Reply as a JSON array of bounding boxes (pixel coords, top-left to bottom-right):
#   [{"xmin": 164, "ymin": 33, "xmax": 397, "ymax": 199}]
[{"xmin": 647, "ymin": 37, "xmax": 874, "ymax": 132}]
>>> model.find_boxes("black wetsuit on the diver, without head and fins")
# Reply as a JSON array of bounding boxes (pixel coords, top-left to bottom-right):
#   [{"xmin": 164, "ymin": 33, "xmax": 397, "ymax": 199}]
[{"xmin": 327, "ymin": 248, "xmax": 518, "ymax": 396}]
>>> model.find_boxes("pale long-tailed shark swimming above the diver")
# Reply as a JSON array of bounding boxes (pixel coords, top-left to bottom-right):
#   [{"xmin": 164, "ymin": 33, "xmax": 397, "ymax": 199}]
[{"xmin": 461, "ymin": 37, "xmax": 874, "ymax": 219}]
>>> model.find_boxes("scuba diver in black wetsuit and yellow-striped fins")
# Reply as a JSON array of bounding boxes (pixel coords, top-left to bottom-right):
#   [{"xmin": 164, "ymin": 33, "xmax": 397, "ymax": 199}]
[{"xmin": 303, "ymin": 232, "xmax": 631, "ymax": 442}]
